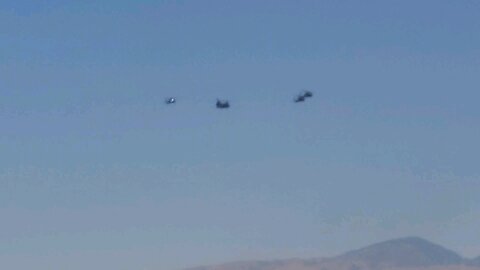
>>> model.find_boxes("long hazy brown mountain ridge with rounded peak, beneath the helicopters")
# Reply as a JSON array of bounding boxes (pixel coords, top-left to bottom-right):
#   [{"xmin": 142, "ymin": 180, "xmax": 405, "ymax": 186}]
[{"xmin": 187, "ymin": 237, "xmax": 480, "ymax": 270}]
